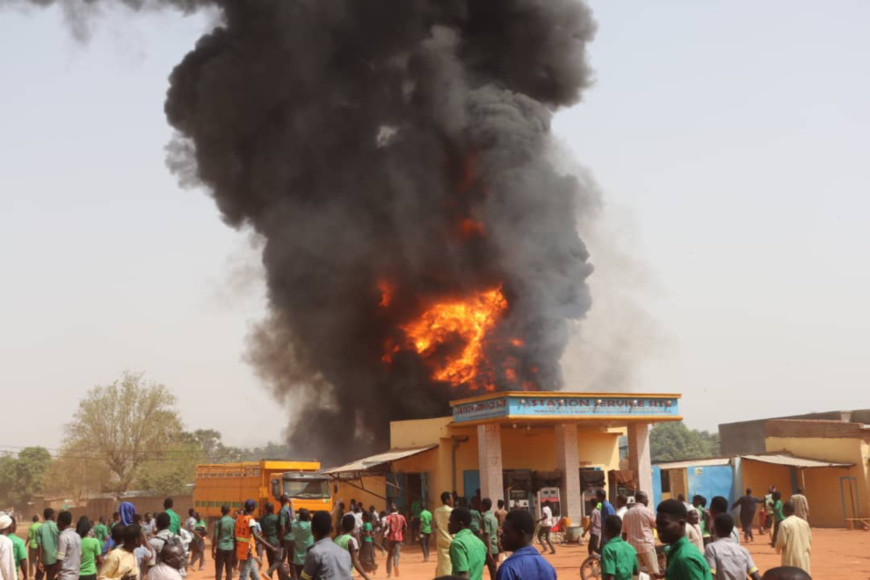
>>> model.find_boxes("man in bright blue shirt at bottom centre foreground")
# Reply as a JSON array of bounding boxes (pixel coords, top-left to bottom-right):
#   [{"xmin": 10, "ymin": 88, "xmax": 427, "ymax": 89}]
[{"xmin": 496, "ymin": 510, "xmax": 556, "ymax": 580}]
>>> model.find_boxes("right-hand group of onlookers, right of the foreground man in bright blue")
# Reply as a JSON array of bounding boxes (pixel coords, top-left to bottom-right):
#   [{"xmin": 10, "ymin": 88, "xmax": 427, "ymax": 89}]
[{"xmin": 580, "ymin": 488, "xmax": 812, "ymax": 580}]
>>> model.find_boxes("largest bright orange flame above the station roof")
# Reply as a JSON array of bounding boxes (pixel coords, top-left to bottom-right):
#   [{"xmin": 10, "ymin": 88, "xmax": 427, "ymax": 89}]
[{"xmin": 402, "ymin": 288, "xmax": 508, "ymax": 390}]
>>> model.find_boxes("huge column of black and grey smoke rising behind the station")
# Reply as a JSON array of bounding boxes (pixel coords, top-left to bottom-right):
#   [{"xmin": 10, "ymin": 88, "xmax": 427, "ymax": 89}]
[{"xmin": 17, "ymin": 0, "xmax": 595, "ymax": 461}]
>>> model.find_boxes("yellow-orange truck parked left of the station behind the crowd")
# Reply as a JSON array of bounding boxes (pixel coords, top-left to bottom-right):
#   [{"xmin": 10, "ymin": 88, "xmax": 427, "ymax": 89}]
[{"xmin": 193, "ymin": 460, "xmax": 332, "ymax": 520}]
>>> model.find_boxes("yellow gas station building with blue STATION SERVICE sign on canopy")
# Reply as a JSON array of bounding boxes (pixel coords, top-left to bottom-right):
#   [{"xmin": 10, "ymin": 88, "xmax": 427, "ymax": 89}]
[{"xmin": 325, "ymin": 391, "xmax": 682, "ymax": 522}]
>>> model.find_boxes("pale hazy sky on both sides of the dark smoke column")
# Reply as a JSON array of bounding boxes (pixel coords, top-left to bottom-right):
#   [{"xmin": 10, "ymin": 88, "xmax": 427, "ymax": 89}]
[{"xmin": 0, "ymin": 0, "xmax": 870, "ymax": 450}]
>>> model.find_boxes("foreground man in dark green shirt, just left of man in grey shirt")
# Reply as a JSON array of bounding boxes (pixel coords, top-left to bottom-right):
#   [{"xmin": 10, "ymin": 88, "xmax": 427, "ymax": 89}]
[{"xmin": 656, "ymin": 499, "xmax": 713, "ymax": 580}]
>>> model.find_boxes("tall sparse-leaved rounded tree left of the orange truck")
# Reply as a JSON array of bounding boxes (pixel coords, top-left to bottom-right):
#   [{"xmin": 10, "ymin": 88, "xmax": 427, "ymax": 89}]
[{"xmin": 64, "ymin": 373, "xmax": 181, "ymax": 494}]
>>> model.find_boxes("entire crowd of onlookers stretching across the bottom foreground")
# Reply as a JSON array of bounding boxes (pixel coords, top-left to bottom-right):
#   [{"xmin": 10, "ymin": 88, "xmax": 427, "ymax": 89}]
[{"xmin": 0, "ymin": 488, "xmax": 812, "ymax": 580}]
